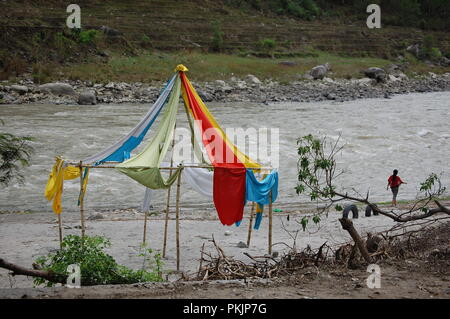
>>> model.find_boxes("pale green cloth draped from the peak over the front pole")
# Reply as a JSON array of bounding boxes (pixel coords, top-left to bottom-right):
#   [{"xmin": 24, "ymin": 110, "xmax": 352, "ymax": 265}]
[{"xmin": 116, "ymin": 77, "xmax": 182, "ymax": 189}]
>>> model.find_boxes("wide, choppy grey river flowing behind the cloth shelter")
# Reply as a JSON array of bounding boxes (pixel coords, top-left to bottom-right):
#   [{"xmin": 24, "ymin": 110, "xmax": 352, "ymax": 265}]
[{"xmin": 0, "ymin": 92, "xmax": 450, "ymax": 211}]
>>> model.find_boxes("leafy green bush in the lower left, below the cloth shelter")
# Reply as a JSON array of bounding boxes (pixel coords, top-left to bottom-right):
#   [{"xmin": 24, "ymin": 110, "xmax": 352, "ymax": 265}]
[{"xmin": 34, "ymin": 235, "xmax": 163, "ymax": 287}]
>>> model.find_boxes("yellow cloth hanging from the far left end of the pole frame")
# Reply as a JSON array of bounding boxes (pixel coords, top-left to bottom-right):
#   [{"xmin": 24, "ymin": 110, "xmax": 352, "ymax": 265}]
[{"xmin": 45, "ymin": 157, "xmax": 81, "ymax": 214}]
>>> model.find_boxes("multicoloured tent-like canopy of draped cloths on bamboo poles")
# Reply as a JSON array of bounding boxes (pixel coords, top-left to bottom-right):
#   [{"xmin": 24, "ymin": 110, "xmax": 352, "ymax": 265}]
[{"xmin": 45, "ymin": 65, "xmax": 278, "ymax": 224}]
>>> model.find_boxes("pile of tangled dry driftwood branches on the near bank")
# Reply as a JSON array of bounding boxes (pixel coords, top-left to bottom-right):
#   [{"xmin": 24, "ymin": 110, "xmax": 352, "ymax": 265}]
[{"xmin": 192, "ymin": 238, "xmax": 329, "ymax": 280}]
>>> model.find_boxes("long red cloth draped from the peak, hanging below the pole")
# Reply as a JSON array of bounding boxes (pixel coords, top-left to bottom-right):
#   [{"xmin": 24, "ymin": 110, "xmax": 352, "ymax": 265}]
[{"xmin": 180, "ymin": 72, "xmax": 246, "ymax": 226}]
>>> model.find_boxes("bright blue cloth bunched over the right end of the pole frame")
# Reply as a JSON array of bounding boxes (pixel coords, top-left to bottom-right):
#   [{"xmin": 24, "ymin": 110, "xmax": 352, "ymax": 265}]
[{"xmin": 236, "ymin": 169, "xmax": 278, "ymax": 230}]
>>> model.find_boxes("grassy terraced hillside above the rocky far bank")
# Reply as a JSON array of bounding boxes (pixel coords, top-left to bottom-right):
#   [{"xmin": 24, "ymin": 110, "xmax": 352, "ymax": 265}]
[{"xmin": 0, "ymin": 0, "xmax": 450, "ymax": 79}]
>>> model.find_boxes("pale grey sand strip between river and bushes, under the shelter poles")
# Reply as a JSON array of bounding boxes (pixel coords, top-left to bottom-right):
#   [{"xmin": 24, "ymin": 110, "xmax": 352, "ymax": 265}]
[{"xmin": 0, "ymin": 206, "xmax": 402, "ymax": 288}]
